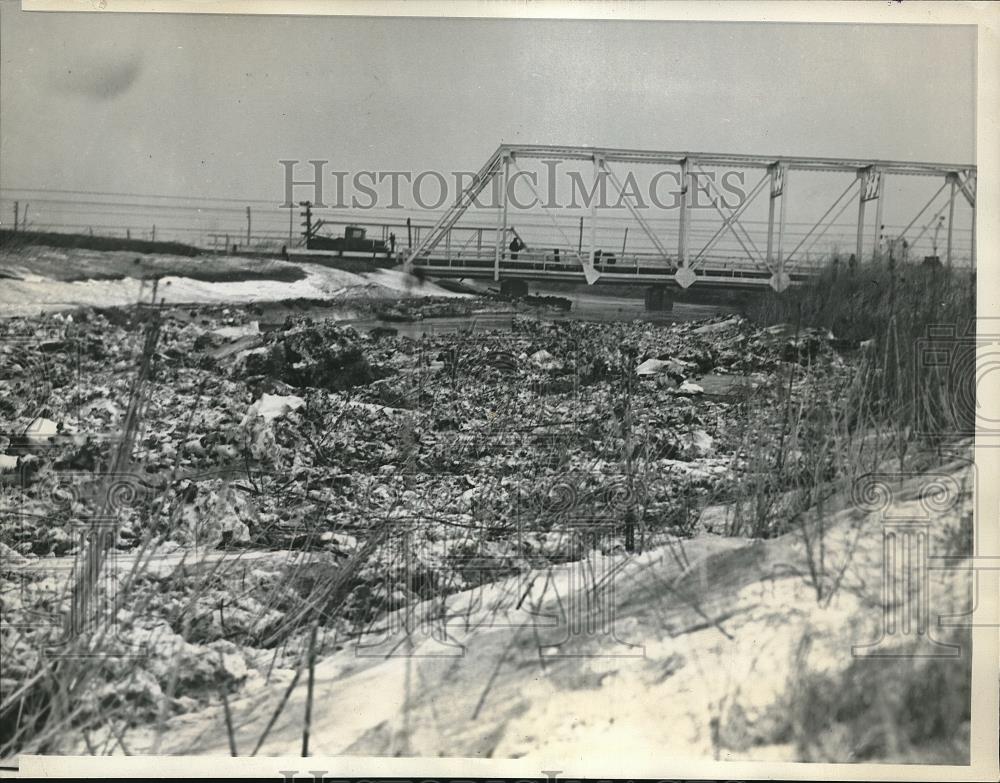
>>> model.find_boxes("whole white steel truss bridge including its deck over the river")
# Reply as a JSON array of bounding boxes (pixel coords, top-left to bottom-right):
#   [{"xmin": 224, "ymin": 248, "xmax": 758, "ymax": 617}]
[{"xmin": 405, "ymin": 144, "xmax": 976, "ymax": 291}]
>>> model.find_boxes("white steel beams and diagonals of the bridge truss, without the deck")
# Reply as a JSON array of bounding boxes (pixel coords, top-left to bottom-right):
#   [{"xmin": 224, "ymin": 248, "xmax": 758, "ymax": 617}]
[{"xmin": 406, "ymin": 144, "xmax": 976, "ymax": 291}]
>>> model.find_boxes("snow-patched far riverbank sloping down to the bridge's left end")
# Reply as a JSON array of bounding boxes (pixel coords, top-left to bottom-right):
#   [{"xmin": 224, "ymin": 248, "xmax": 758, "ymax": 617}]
[{"xmin": 0, "ymin": 245, "xmax": 737, "ymax": 322}]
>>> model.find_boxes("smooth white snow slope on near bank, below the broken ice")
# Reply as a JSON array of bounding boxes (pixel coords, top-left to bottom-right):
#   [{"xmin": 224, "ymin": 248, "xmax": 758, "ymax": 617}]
[{"xmin": 115, "ymin": 467, "xmax": 970, "ymax": 774}]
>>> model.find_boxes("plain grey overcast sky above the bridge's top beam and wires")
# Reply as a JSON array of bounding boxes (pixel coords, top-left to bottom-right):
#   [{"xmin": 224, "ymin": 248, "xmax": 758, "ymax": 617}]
[{"xmin": 0, "ymin": 9, "xmax": 975, "ymax": 200}]
